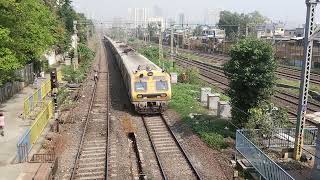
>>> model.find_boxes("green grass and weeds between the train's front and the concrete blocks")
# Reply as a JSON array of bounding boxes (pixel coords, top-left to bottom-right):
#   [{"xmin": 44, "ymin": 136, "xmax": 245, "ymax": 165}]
[{"xmin": 169, "ymin": 83, "xmax": 235, "ymax": 150}]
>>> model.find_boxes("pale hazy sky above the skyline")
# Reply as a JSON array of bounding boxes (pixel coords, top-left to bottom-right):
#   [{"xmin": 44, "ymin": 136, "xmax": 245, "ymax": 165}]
[{"xmin": 73, "ymin": 0, "xmax": 304, "ymax": 26}]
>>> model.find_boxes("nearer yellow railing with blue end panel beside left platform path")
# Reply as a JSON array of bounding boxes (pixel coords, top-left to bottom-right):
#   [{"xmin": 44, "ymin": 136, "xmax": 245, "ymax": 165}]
[{"xmin": 17, "ymin": 100, "xmax": 53, "ymax": 162}]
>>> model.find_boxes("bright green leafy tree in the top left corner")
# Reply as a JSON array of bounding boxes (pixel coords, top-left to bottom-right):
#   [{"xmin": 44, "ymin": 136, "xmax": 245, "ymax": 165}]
[{"xmin": 0, "ymin": 0, "xmax": 58, "ymax": 64}]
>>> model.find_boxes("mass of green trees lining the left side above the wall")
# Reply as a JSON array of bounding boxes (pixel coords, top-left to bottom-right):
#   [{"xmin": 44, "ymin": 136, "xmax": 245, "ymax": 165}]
[{"xmin": 0, "ymin": 0, "xmax": 92, "ymax": 86}]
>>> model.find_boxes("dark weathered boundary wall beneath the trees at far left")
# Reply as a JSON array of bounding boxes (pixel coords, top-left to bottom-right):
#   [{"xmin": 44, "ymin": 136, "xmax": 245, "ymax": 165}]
[{"xmin": 0, "ymin": 64, "xmax": 34, "ymax": 103}]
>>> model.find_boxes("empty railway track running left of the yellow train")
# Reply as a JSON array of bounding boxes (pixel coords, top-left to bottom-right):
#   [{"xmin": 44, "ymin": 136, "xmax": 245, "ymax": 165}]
[{"xmin": 70, "ymin": 43, "xmax": 109, "ymax": 179}]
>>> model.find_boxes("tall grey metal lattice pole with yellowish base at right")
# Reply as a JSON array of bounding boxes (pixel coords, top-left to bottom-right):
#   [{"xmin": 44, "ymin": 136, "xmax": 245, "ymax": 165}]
[{"xmin": 294, "ymin": 0, "xmax": 320, "ymax": 162}]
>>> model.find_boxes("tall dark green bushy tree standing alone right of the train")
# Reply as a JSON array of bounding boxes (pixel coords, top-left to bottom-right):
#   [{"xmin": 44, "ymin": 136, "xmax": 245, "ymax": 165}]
[{"xmin": 224, "ymin": 38, "xmax": 277, "ymax": 127}]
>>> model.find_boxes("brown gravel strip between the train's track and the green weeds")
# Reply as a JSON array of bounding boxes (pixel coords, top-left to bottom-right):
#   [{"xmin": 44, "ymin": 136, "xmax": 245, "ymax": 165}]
[{"xmin": 165, "ymin": 110, "xmax": 234, "ymax": 180}]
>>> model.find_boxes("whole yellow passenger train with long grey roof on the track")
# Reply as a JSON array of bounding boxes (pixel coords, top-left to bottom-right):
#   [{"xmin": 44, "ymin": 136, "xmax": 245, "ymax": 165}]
[{"xmin": 104, "ymin": 36, "xmax": 171, "ymax": 114}]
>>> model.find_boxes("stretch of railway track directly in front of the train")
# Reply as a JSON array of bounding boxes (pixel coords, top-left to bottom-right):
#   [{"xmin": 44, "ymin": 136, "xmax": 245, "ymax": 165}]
[{"xmin": 142, "ymin": 115, "xmax": 202, "ymax": 180}]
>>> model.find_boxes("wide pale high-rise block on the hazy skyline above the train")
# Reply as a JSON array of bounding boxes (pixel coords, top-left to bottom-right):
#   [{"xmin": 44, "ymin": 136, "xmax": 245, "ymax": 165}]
[{"xmin": 128, "ymin": 8, "xmax": 150, "ymax": 28}]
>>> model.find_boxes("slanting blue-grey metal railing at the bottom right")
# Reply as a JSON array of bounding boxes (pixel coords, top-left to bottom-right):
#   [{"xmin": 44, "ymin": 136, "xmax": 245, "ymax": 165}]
[{"xmin": 236, "ymin": 130, "xmax": 293, "ymax": 180}]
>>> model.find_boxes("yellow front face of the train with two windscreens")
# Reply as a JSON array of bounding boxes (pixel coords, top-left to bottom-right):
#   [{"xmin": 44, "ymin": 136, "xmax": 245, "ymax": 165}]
[{"xmin": 131, "ymin": 70, "xmax": 171, "ymax": 114}]
